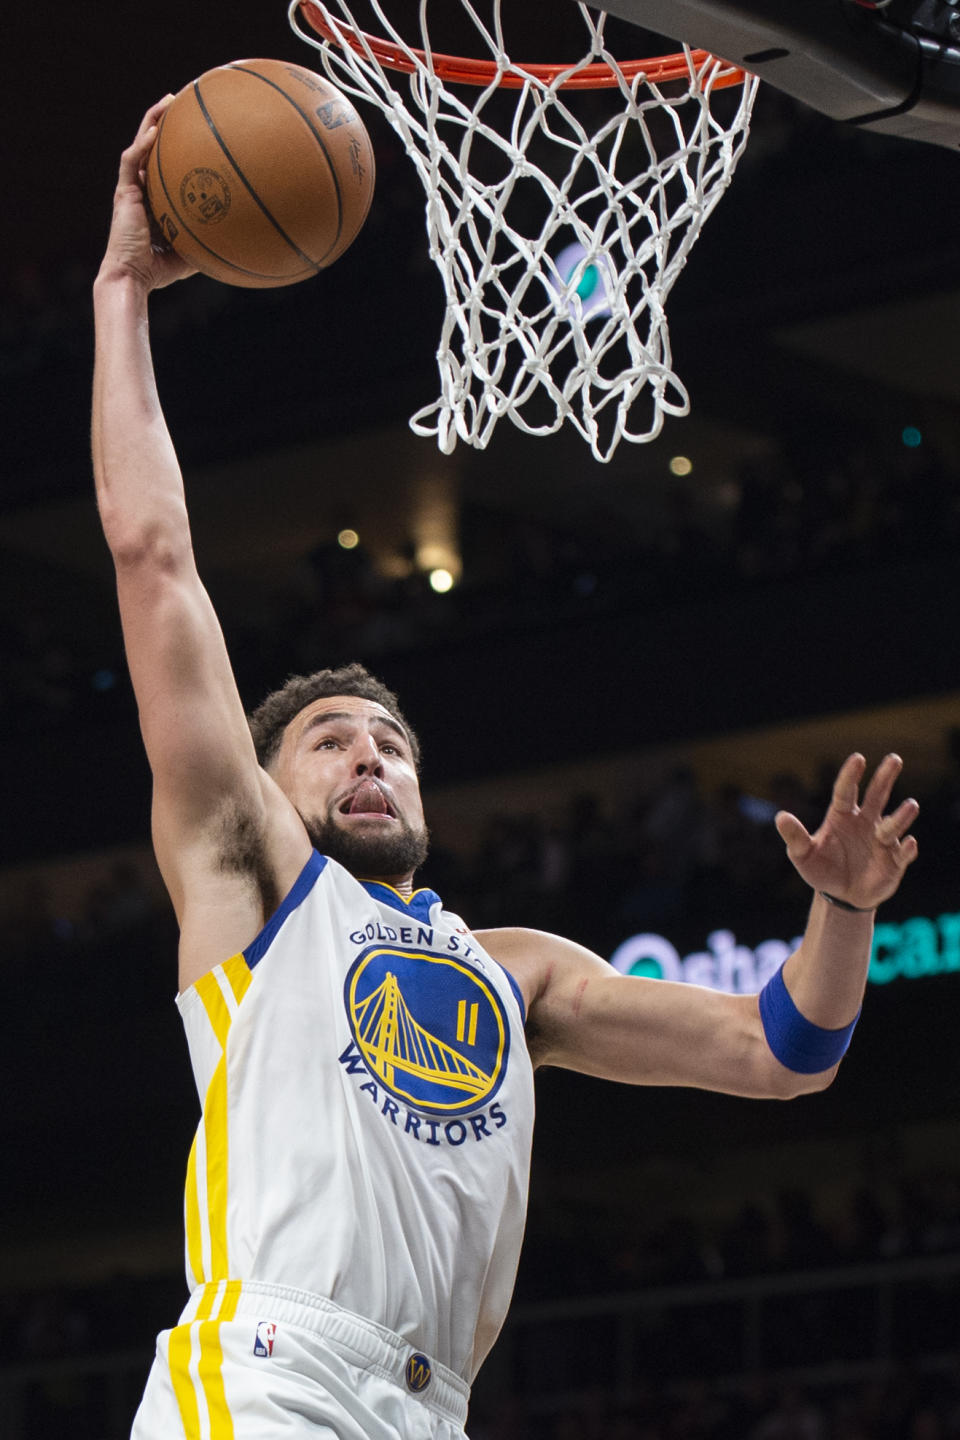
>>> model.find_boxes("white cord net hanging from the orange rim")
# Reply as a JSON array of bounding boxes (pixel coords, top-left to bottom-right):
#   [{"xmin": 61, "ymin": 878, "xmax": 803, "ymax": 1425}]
[{"xmin": 289, "ymin": 0, "xmax": 757, "ymax": 461}]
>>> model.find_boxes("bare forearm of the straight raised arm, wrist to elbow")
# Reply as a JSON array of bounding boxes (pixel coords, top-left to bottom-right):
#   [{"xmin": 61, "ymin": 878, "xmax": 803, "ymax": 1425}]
[{"xmin": 92, "ymin": 272, "xmax": 190, "ymax": 562}]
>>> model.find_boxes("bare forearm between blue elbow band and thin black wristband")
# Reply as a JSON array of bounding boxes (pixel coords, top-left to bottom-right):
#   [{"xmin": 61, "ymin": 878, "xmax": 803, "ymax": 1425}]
[{"xmin": 783, "ymin": 894, "xmax": 874, "ymax": 1030}]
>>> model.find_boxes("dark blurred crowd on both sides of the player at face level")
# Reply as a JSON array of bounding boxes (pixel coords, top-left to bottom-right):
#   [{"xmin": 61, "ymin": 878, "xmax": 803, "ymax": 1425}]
[{"xmin": 3, "ymin": 729, "xmax": 960, "ymax": 955}]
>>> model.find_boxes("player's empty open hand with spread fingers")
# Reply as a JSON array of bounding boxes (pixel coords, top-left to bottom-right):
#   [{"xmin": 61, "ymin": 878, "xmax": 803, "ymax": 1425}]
[{"xmin": 774, "ymin": 755, "xmax": 920, "ymax": 910}]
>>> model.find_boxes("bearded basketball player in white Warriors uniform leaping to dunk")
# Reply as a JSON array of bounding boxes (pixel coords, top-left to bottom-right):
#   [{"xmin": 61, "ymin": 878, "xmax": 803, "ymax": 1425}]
[{"xmin": 94, "ymin": 102, "xmax": 917, "ymax": 1440}]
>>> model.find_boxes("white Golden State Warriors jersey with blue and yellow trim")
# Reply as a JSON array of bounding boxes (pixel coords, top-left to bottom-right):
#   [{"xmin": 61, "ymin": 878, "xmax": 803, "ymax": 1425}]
[{"xmin": 177, "ymin": 852, "xmax": 534, "ymax": 1381}]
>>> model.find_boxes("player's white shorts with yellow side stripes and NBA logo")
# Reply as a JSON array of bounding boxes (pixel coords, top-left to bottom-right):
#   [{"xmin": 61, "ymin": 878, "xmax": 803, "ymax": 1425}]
[{"xmin": 131, "ymin": 1280, "xmax": 469, "ymax": 1440}]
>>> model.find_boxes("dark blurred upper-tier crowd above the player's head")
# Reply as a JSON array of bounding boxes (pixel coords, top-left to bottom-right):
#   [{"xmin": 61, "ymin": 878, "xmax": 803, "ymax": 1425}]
[{"xmin": 0, "ymin": 423, "xmax": 960, "ymax": 736}]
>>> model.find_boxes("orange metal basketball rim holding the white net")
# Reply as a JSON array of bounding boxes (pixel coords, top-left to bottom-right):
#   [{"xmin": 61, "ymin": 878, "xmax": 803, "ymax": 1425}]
[{"xmin": 299, "ymin": 0, "xmax": 748, "ymax": 89}]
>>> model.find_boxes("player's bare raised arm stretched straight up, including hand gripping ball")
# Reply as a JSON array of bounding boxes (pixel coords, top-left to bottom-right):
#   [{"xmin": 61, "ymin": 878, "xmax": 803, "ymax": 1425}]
[{"xmin": 92, "ymin": 101, "xmax": 303, "ymax": 953}]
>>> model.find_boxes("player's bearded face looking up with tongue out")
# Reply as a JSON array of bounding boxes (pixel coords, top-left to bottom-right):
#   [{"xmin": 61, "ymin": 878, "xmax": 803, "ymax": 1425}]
[{"xmin": 271, "ymin": 696, "xmax": 427, "ymax": 883}]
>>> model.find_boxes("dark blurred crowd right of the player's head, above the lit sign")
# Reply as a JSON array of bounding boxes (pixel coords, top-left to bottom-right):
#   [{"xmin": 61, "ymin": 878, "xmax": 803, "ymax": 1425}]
[{"xmin": 430, "ymin": 733, "xmax": 960, "ymax": 953}]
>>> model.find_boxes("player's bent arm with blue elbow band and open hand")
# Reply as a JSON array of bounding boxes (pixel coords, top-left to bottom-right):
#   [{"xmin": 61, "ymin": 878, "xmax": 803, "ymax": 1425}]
[{"xmin": 481, "ymin": 755, "xmax": 917, "ymax": 1097}]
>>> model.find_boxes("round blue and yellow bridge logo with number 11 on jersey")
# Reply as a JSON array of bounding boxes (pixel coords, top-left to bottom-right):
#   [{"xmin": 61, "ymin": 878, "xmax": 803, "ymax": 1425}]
[{"xmin": 344, "ymin": 946, "xmax": 510, "ymax": 1115}]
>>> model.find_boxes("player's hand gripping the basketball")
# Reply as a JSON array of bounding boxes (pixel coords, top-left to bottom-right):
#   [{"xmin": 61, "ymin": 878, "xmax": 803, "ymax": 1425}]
[{"xmin": 101, "ymin": 95, "xmax": 196, "ymax": 289}]
